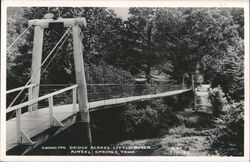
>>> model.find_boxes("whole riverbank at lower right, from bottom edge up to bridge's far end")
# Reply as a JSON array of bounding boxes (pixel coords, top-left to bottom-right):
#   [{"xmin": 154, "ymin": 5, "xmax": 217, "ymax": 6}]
[{"xmin": 118, "ymin": 86, "xmax": 214, "ymax": 156}]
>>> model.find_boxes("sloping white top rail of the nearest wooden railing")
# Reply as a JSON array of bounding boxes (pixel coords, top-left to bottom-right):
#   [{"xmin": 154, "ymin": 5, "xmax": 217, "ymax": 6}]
[{"xmin": 6, "ymin": 85, "xmax": 78, "ymax": 113}]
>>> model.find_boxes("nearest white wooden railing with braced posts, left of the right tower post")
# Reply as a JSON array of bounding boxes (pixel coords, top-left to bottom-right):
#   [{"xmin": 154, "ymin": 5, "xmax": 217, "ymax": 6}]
[{"xmin": 6, "ymin": 85, "xmax": 77, "ymax": 144}]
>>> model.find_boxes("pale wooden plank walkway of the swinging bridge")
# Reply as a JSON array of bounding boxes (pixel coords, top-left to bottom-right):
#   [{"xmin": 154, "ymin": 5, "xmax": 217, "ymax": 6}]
[{"xmin": 6, "ymin": 89, "xmax": 190, "ymax": 151}]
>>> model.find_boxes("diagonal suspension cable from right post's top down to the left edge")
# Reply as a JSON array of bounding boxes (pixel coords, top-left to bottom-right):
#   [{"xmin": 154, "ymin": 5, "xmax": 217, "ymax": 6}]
[{"xmin": 7, "ymin": 26, "xmax": 72, "ymax": 109}]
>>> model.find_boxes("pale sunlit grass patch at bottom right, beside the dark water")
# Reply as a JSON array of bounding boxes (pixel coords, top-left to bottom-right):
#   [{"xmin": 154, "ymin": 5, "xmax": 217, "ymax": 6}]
[{"xmin": 116, "ymin": 125, "xmax": 214, "ymax": 156}]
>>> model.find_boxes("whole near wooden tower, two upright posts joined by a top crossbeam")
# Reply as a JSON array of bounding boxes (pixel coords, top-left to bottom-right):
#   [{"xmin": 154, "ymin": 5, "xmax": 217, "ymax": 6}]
[{"xmin": 28, "ymin": 18, "xmax": 92, "ymax": 146}]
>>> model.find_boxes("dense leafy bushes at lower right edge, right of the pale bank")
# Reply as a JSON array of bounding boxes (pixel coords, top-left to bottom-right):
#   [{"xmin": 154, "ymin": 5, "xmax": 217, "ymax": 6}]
[{"xmin": 209, "ymin": 86, "xmax": 244, "ymax": 156}]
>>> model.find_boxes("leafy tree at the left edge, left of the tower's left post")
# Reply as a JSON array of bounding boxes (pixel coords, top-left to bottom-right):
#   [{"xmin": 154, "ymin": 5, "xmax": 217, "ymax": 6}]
[{"xmin": 7, "ymin": 7, "xmax": 30, "ymax": 89}]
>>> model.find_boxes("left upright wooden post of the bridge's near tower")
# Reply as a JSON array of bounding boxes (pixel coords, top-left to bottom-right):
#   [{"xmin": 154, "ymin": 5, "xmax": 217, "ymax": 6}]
[{"xmin": 31, "ymin": 26, "xmax": 44, "ymax": 110}]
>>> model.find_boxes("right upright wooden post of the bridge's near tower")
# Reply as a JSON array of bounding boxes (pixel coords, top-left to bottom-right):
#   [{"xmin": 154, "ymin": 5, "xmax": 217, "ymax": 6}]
[{"xmin": 73, "ymin": 23, "xmax": 92, "ymax": 146}]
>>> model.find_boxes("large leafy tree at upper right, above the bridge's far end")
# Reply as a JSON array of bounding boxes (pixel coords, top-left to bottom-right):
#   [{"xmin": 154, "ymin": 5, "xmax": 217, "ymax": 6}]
[{"xmin": 153, "ymin": 8, "xmax": 243, "ymax": 83}]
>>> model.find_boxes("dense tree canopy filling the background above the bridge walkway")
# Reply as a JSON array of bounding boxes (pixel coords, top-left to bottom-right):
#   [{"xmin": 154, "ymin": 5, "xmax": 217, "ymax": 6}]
[{"xmin": 8, "ymin": 7, "xmax": 244, "ymax": 86}]
